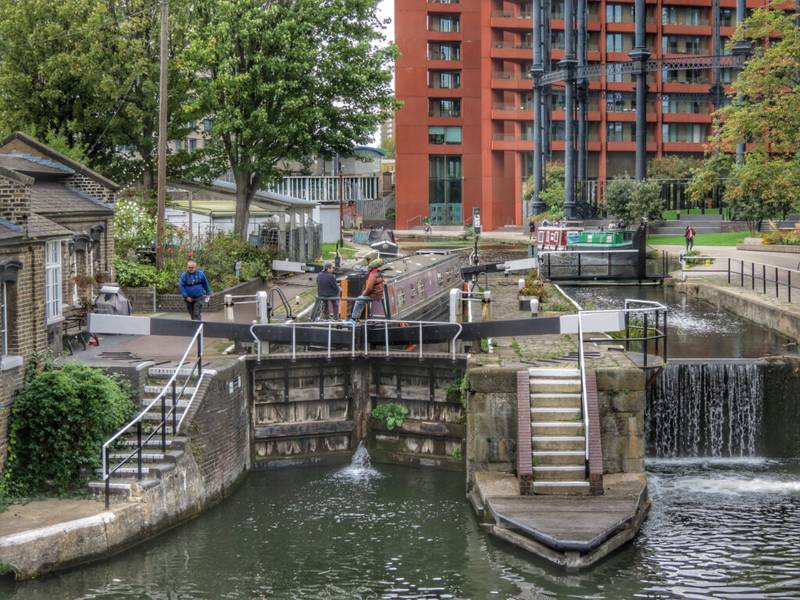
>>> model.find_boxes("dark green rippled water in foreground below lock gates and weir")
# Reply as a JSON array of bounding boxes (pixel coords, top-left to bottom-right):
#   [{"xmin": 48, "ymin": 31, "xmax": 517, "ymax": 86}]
[{"xmin": 0, "ymin": 459, "xmax": 800, "ymax": 600}]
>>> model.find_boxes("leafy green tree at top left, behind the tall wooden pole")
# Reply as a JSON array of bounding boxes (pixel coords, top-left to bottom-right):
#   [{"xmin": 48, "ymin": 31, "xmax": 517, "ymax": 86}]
[{"xmin": 0, "ymin": 0, "xmax": 194, "ymax": 187}]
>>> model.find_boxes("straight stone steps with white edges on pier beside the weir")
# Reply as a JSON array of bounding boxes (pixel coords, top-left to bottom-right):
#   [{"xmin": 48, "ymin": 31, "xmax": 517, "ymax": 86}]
[{"xmin": 528, "ymin": 368, "xmax": 589, "ymax": 494}]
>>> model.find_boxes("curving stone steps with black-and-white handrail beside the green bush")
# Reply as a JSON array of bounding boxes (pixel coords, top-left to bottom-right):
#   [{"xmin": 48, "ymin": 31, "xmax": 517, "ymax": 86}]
[{"xmin": 89, "ymin": 366, "xmax": 216, "ymax": 500}]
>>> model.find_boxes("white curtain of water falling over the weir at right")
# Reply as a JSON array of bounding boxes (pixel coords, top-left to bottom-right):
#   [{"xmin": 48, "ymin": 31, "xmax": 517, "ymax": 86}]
[{"xmin": 645, "ymin": 361, "xmax": 764, "ymax": 457}]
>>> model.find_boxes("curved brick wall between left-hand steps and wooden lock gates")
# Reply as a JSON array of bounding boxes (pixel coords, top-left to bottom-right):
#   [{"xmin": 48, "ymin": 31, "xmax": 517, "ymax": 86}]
[{"xmin": 188, "ymin": 361, "xmax": 250, "ymax": 500}]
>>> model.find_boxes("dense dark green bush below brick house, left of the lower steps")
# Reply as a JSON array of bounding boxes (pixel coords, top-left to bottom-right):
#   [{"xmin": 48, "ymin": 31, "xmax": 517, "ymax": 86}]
[{"xmin": 5, "ymin": 364, "xmax": 134, "ymax": 496}]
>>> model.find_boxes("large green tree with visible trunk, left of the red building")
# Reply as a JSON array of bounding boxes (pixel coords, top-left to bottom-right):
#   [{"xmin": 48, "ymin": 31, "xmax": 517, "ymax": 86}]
[{"xmin": 185, "ymin": 0, "xmax": 397, "ymax": 237}]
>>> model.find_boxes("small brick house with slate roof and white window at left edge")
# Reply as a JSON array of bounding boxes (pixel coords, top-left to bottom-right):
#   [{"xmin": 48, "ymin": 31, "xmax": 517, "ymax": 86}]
[{"xmin": 0, "ymin": 133, "xmax": 119, "ymax": 469}]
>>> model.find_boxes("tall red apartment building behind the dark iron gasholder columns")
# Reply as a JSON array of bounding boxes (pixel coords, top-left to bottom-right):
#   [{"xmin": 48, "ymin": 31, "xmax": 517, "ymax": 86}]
[{"xmin": 395, "ymin": 0, "xmax": 765, "ymax": 229}]
